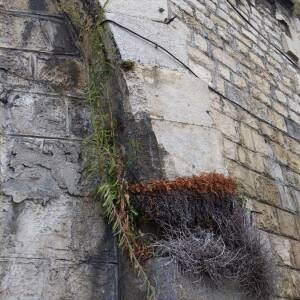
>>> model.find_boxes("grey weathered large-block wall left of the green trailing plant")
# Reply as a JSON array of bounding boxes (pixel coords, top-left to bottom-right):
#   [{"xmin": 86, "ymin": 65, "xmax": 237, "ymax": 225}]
[{"xmin": 0, "ymin": 0, "xmax": 118, "ymax": 300}]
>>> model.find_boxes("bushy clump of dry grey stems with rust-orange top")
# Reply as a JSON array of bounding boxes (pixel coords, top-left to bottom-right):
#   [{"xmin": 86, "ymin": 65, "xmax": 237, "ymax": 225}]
[{"xmin": 130, "ymin": 173, "xmax": 273, "ymax": 299}]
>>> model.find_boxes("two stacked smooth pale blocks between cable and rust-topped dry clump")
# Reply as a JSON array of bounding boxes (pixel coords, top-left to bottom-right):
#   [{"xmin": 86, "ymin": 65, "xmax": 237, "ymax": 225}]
[{"xmin": 118, "ymin": 67, "xmax": 226, "ymax": 178}]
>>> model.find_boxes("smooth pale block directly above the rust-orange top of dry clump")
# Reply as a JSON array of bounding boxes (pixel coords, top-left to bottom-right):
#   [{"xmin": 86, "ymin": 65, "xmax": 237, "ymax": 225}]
[{"xmin": 152, "ymin": 120, "xmax": 227, "ymax": 178}]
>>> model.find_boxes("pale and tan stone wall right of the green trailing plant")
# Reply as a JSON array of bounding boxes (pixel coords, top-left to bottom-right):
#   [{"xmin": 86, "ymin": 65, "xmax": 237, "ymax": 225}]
[{"xmin": 103, "ymin": 0, "xmax": 300, "ymax": 299}]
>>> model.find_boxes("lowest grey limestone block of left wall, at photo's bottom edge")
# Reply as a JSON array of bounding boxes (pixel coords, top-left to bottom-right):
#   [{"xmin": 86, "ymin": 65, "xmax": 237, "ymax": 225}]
[{"xmin": 0, "ymin": 257, "xmax": 118, "ymax": 300}]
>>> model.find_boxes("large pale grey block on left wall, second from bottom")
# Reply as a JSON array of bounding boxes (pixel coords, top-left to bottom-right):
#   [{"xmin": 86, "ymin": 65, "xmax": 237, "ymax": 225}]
[{"xmin": 0, "ymin": 195, "xmax": 117, "ymax": 262}]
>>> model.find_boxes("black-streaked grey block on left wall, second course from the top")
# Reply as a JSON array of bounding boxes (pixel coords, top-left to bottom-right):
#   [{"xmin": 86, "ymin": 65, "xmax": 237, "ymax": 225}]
[{"xmin": 0, "ymin": 13, "xmax": 78, "ymax": 54}]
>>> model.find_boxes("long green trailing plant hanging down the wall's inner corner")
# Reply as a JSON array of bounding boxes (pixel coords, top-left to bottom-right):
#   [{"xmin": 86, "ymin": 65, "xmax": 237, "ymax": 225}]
[{"xmin": 60, "ymin": 1, "xmax": 155, "ymax": 300}]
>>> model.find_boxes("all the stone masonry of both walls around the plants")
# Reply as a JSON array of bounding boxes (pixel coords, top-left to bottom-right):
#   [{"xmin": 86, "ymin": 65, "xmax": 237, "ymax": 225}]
[{"xmin": 0, "ymin": 0, "xmax": 300, "ymax": 300}]
